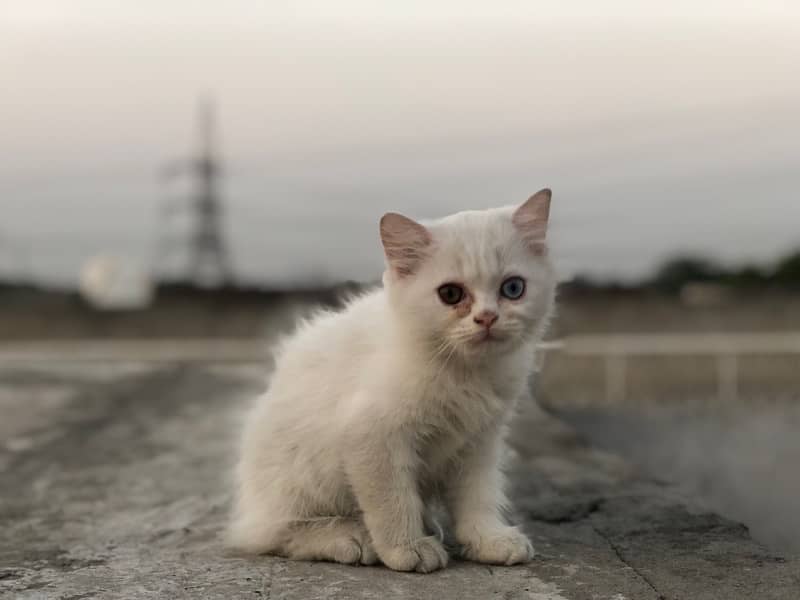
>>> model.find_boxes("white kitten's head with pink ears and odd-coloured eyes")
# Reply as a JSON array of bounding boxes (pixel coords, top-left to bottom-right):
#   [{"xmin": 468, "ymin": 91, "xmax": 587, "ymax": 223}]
[{"xmin": 381, "ymin": 189, "xmax": 556, "ymax": 359}]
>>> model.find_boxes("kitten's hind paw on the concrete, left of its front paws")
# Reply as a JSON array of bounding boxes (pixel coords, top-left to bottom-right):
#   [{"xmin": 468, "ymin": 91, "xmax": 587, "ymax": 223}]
[{"xmin": 283, "ymin": 517, "xmax": 378, "ymax": 565}]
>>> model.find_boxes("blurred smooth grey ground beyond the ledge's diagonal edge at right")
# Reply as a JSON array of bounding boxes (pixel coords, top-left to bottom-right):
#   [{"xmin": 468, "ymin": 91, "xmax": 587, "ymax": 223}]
[{"xmin": 556, "ymin": 395, "xmax": 800, "ymax": 556}]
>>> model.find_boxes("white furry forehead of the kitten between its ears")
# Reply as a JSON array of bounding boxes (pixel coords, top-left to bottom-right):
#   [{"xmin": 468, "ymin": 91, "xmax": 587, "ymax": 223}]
[{"xmin": 428, "ymin": 207, "xmax": 527, "ymax": 278}]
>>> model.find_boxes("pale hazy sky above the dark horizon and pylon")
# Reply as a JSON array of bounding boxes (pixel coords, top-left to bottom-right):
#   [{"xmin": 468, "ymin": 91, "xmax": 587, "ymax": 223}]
[{"xmin": 0, "ymin": 0, "xmax": 800, "ymax": 283}]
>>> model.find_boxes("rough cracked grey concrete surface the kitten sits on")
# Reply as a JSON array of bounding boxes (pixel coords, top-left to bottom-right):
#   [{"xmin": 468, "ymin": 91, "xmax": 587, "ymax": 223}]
[{"xmin": 0, "ymin": 357, "xmax": 800, "ymax": 600}]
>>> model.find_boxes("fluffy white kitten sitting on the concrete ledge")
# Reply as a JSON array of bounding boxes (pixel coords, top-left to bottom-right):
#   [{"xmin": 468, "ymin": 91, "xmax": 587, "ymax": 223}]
[{"xmin": 230, "ymin": 190, "xmax": 555, "ymax": 573}]
